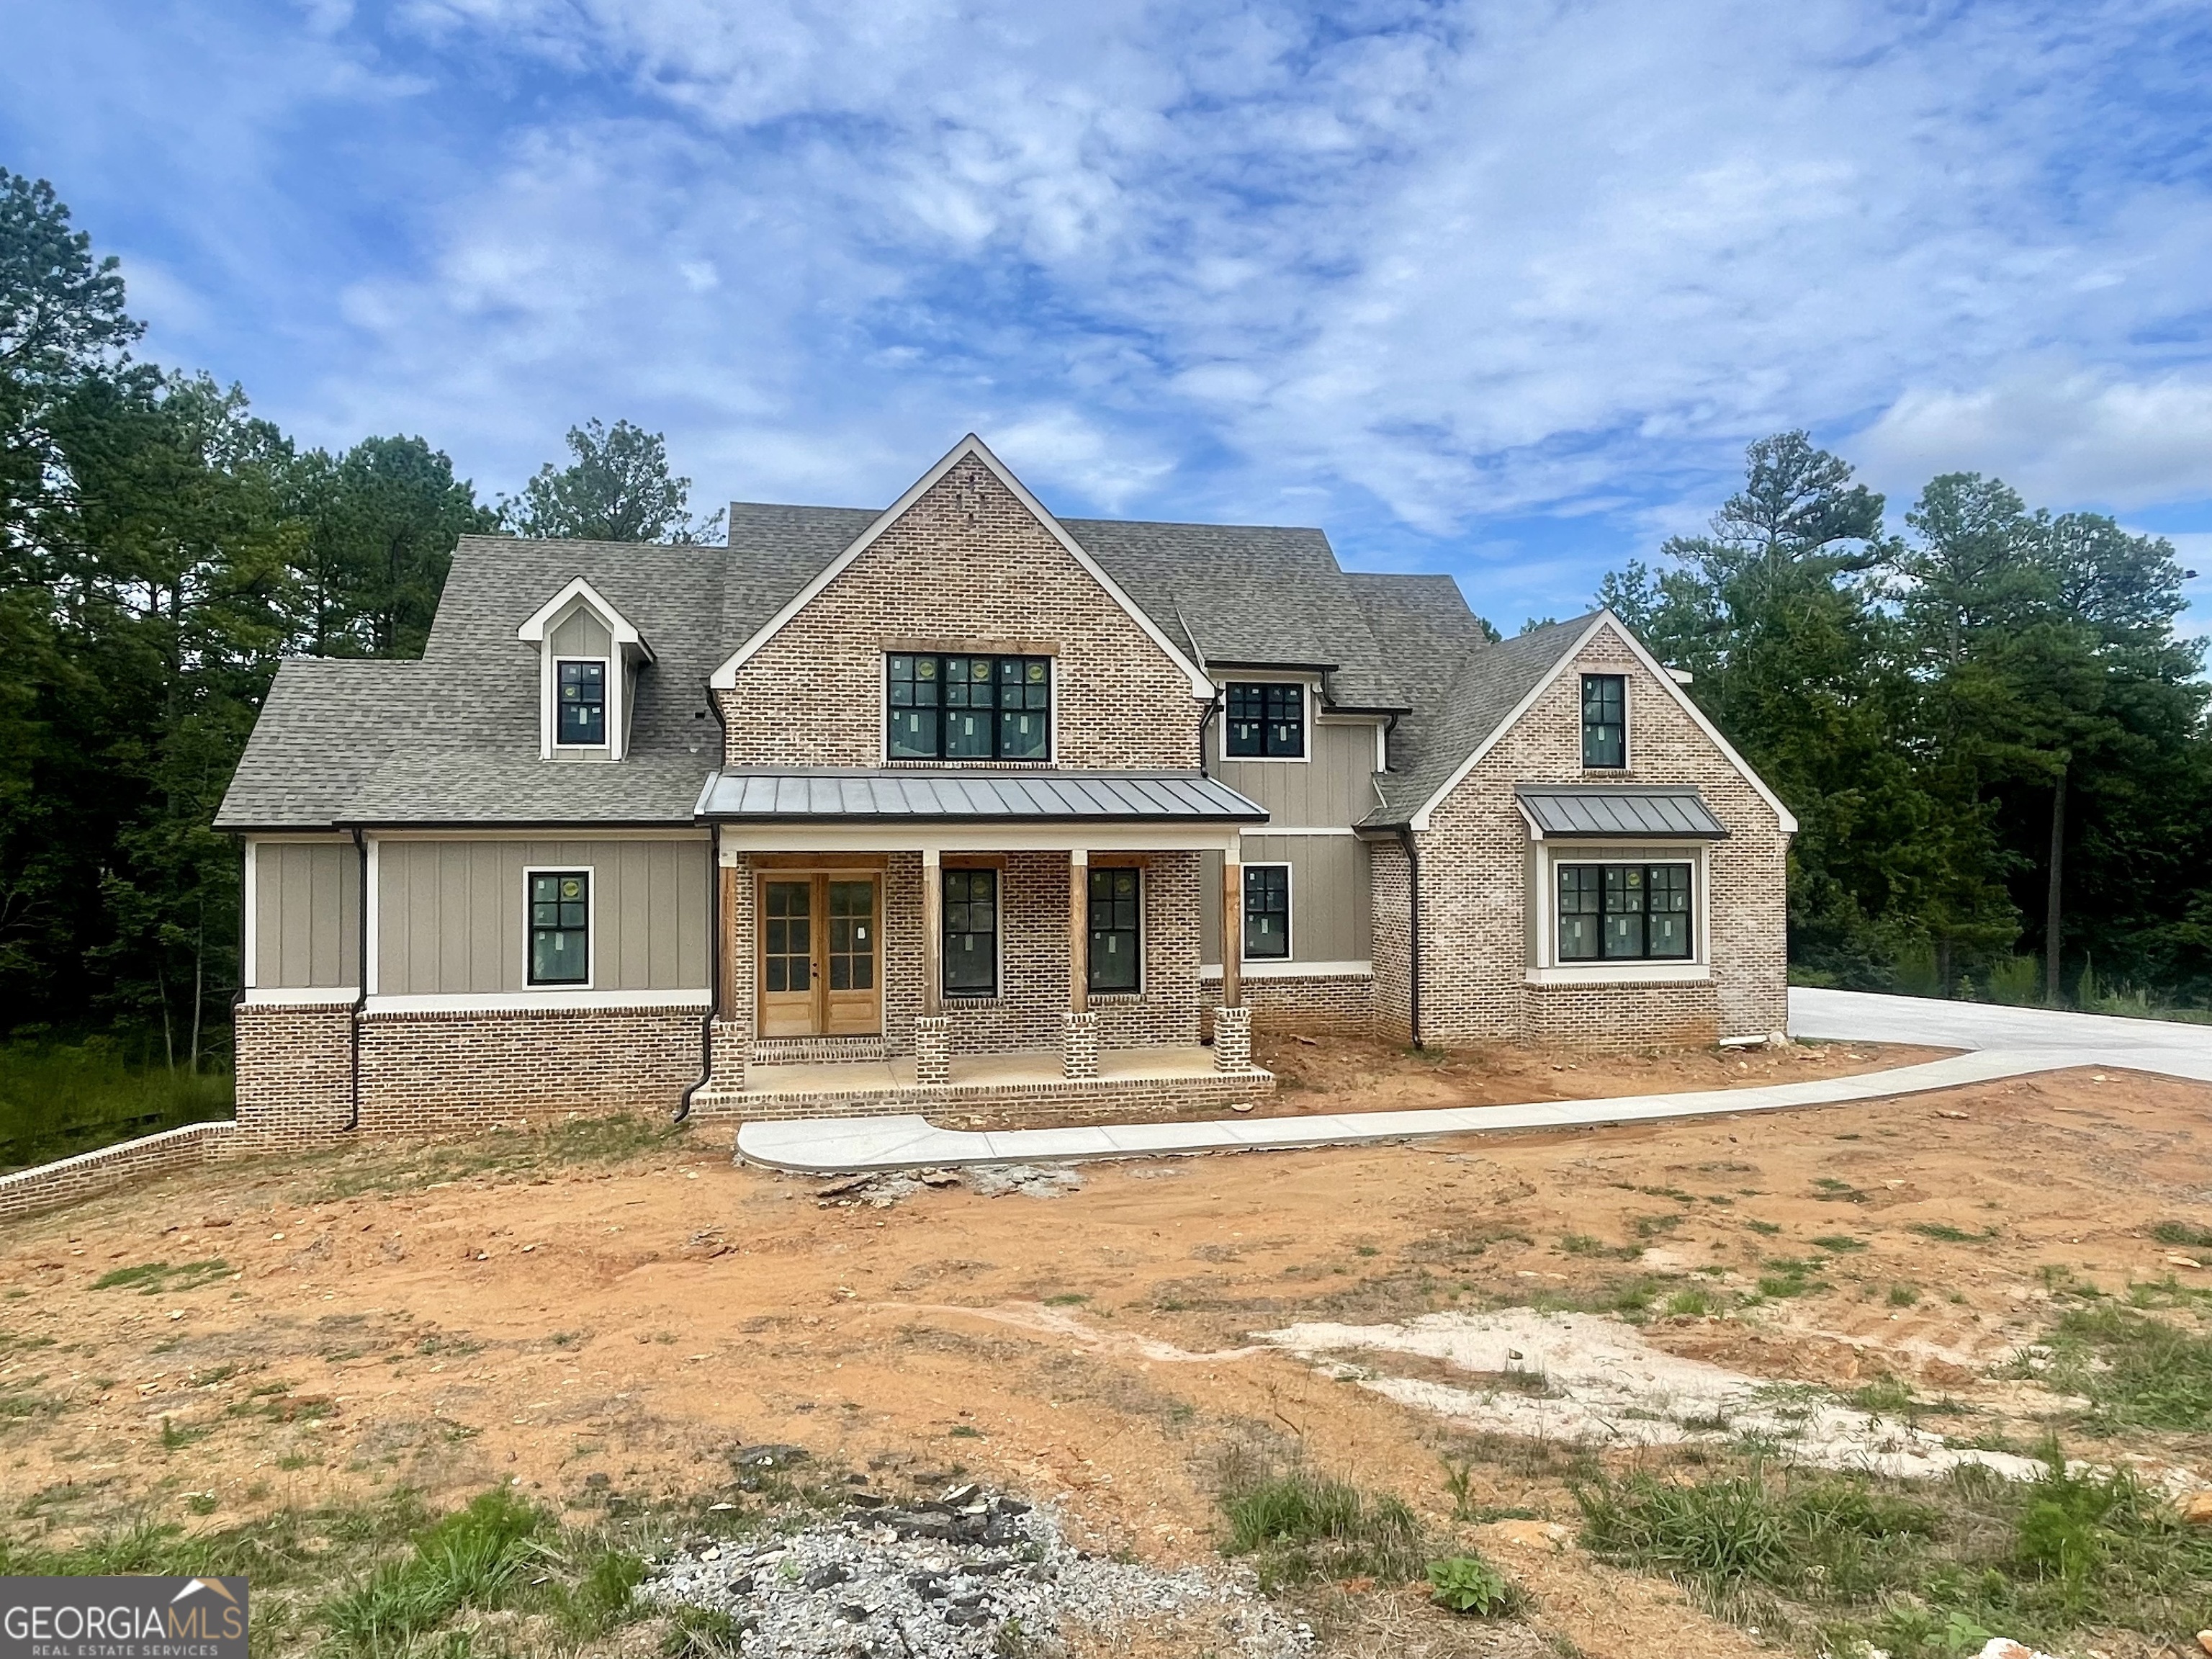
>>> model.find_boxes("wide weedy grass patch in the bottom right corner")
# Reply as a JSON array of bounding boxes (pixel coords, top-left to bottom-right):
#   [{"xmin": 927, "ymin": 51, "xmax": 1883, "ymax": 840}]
[{"xmin": 1575, "ymin": 1449, "xmax": 2212, "ymax": 1659}]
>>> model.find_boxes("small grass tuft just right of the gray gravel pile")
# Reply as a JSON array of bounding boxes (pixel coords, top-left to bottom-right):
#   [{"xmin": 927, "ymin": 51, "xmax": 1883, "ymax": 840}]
[{"xmin": 1221, "ymin": 1467, "xmax": 1426, "ymax": 1588}]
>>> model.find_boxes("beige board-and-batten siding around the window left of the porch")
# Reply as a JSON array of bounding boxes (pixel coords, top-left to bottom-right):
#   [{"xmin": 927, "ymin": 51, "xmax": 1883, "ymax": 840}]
[{"xmin": 376, "ymin": 836, "xmax": 712, "ymax": 995}]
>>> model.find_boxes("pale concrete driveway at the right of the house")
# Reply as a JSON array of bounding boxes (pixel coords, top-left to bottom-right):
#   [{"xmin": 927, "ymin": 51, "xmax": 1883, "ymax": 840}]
[{"xmin": 1789, "ymin": 986, "xmax": 2212, "ymax": 1082}]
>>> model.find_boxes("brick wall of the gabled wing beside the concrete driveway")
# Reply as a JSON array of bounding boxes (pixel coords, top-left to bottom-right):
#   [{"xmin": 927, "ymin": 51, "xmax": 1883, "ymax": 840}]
[{"xmin": 1416, "ymin": 628, "xmax": 1789, "ymax": 1042}]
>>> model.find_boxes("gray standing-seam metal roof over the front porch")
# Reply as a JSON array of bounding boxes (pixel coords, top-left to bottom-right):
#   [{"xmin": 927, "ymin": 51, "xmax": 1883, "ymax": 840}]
[{"xmin": 697, "ymin": 768, "xmax": 1267, "ymax": 825}]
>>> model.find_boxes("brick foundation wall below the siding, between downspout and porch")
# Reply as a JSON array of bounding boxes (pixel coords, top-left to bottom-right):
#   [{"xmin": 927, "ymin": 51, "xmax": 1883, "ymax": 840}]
[{"xmin": 361, "ymin": 1007, "xmax": 703, "ymax": 1135}]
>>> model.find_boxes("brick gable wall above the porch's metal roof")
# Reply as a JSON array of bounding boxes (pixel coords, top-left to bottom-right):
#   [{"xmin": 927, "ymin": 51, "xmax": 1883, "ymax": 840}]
[{"xmin": 714, "ymin": 456, "xmax": 1205, "ymax": 770}]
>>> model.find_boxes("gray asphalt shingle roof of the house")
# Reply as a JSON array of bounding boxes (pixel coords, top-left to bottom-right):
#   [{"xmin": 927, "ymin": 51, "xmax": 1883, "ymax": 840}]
[{"xmin": 217, "ymin": 490, "xmax": 1610, "ymax": 830}]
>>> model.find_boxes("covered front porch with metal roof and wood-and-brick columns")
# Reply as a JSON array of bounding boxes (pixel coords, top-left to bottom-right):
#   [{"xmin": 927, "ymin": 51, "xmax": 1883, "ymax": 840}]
[{"xmin": 693, "ymin": 770, "xmax": 1274, "ymax": 1122}]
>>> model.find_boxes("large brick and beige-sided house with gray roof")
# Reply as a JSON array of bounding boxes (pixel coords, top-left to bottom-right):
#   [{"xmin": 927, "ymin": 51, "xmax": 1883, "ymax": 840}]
[{"xmin": 217, "ymin": 438, "xmax": 1794, "ymax": 1143}]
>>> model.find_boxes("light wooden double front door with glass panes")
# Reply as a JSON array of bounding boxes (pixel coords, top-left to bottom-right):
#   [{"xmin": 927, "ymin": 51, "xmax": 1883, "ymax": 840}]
[{"xmin": 755, "ymin": 869, "xmax": 883, "ymax": 1038}]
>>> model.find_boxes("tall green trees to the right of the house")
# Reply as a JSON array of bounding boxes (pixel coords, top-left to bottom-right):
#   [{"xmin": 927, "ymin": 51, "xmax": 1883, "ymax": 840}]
[{"xmin": 1599, "ymin": 431, "xmax": 2212, "ymax": 1007}]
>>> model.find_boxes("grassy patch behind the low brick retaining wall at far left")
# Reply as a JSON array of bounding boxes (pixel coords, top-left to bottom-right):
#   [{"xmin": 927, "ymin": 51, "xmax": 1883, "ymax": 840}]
[{"xmin": 0, "ymin": 1035, "xmax": 230, "ymax": 1170}]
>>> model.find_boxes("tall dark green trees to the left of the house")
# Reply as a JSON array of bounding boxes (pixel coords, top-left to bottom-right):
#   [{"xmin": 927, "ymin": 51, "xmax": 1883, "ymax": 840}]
[{"xmin": 0, "ymin": 168, "xmax": 721, "ymax": 1071}]
